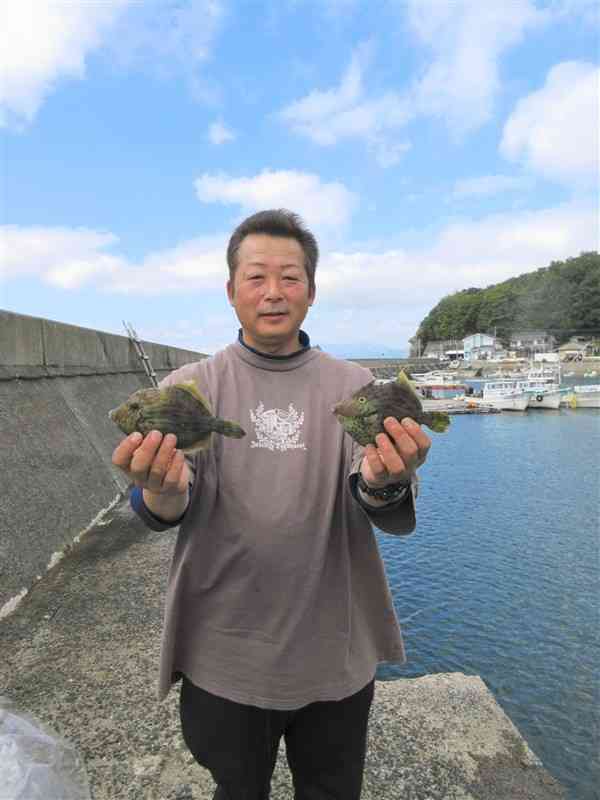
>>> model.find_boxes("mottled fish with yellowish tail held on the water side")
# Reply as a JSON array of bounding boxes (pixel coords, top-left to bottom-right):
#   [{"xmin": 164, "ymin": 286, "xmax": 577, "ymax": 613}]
[{"xmin": 333, "ymin": 370, "xmax": 450, "ymax": 445}]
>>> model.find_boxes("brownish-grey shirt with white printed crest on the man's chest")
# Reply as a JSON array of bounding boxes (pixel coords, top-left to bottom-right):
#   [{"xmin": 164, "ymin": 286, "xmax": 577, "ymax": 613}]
[{"xmin": 138, "ymin": 342, "xmax": 416, "ymax": 710}]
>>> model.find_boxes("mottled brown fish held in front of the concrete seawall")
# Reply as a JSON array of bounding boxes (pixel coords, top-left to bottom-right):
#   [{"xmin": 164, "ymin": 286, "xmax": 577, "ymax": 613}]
[{"xmin": 108, "ymin": 381, "xmax": 246, "ymax": 455}]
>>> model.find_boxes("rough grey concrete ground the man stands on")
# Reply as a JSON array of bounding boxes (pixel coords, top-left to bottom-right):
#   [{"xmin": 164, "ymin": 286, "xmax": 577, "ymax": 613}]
[{"xmin": 0, "ymin": 498, "xmax": 565, "ymax": 800}]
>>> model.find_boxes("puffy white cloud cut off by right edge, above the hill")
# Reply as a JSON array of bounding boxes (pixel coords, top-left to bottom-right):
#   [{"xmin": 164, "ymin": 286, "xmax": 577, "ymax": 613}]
[{"xmin": 500, "ymin": 61, "xmax": 600, "ymax": 186}]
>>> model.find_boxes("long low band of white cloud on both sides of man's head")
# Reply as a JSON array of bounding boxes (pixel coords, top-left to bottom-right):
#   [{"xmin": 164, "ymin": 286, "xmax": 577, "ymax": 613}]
[{"xmin": 0, "ymin": 203, "xmax": 598, "ymax": 352}]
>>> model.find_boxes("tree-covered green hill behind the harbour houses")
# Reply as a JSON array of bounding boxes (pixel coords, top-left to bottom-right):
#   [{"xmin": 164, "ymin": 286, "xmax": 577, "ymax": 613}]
[{"xmin": 415, "ymin": 251, "xmax": 600, "ymax": 348}]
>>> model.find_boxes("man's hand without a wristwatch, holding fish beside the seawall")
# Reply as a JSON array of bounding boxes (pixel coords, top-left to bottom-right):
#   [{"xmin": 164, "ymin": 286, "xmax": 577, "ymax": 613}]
[{"xmin": 112, "ymin": 431, "xmax": 191, "ymax": 497}]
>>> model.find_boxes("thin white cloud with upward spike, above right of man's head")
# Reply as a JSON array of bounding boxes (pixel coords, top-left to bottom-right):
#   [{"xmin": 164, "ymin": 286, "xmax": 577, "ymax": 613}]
[{"xmin": 277, "ymin": 45, "xmax": 410, "ymax": 167}]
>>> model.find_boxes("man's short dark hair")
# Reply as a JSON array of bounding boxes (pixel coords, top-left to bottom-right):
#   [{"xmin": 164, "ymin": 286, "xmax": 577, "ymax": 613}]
[{"xmin": 227, "ymin": 208, "xmax": 319, "ymax": 292}]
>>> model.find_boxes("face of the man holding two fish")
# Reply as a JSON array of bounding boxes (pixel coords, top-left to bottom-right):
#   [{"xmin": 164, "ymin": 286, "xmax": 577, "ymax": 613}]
[{"xmin": 227, "ymin": 233, "xmax": 314, "ymax": 355}]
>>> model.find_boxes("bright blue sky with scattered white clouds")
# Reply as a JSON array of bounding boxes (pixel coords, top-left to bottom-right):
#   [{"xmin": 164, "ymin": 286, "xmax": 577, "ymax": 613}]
[{"xmin": 0, "ymin": 0, "xmax": 600, "ymax": 357}]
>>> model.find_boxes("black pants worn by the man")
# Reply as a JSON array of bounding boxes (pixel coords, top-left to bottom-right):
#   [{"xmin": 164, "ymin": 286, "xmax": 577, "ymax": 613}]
[{"xmin": 180, "ymin": 676, "xmax": 374, "ymax": 800}]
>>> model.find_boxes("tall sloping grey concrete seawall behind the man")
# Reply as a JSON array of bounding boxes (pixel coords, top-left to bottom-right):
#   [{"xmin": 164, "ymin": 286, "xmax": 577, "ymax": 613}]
[{"xmin": 0, "ymin": 311, "xmax": 209, "ymax": 616}]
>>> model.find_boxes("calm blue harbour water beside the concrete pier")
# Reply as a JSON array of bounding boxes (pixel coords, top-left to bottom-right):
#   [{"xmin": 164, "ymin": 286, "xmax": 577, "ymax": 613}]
[{"xmin": 377, "ymin": 396, "xmax": 600, "ymax": 800}]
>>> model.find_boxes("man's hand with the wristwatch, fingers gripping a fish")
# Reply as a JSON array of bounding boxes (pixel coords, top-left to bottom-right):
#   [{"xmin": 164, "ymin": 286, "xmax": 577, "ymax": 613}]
[{"xmin": 360, "ymin": 417, "xmax": 431, "ymax": 489}]
